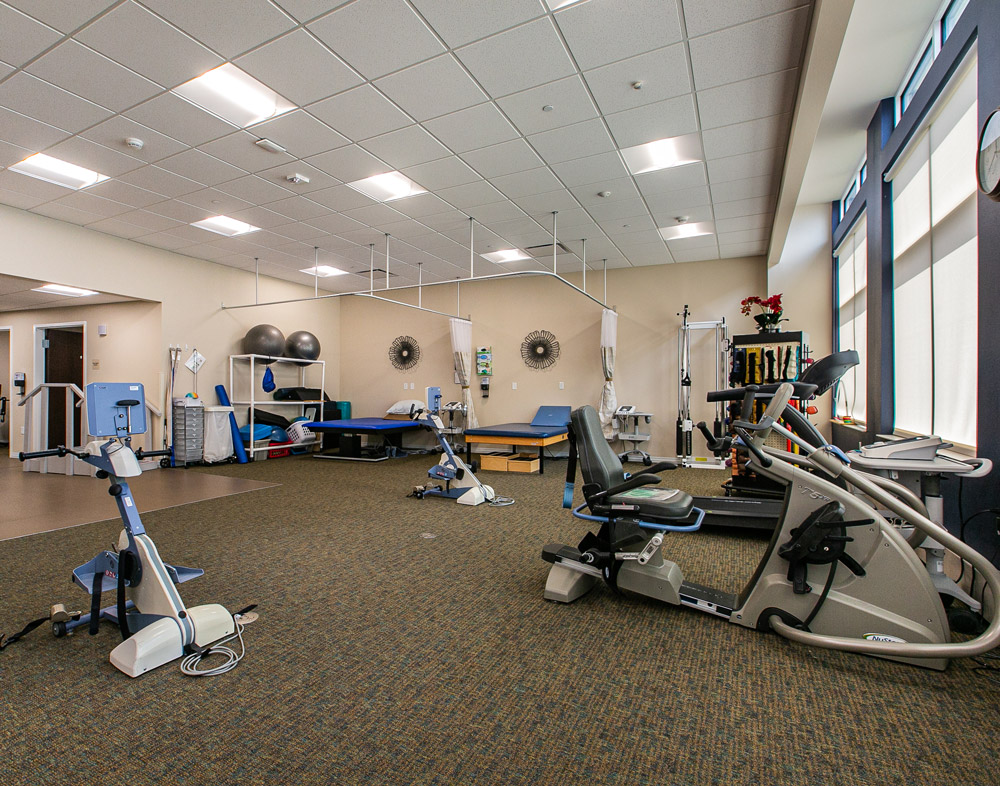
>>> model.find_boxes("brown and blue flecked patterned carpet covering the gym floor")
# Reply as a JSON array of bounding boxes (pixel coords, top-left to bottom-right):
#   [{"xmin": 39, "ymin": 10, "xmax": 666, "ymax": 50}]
[{"xmin": 0, "ymin": 456, "xmax": 1000, "ymax": 786}]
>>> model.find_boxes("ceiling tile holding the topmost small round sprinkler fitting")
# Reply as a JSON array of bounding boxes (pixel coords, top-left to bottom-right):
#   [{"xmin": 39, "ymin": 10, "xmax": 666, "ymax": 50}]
[{"xmin": 584, "ymin": 44, "xmax": 692, "ymax": 115}]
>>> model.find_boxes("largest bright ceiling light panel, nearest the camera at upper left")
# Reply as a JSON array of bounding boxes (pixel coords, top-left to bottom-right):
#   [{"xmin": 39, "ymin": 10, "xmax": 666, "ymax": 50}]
[{"xmin": 173, "ymin": 63, "xmax": 295, "ymax": 128}]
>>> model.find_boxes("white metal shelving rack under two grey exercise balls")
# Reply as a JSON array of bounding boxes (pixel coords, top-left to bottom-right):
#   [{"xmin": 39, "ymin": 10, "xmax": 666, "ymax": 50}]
[{"xmin": 229, "ymin": 355, "xmax": 326, "ymax": 456}]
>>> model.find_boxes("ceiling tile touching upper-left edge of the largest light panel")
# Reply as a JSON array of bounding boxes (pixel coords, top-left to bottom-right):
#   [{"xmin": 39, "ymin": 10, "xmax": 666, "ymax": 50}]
[{"xmin": 75, "ymin": 2, "xmax": 222, "ymax": 88}]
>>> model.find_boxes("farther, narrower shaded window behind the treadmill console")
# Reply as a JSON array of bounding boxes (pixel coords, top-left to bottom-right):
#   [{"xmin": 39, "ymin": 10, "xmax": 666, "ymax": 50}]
[{"xmin": 834, "ymin": 216, "xmax": 868, "ymax": 423}]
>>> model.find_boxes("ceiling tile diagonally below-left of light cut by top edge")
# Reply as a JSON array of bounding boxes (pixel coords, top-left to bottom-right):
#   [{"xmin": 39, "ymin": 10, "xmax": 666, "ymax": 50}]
[{"xmin": 455, "ymin": 17, "xmax": 576, "ymax": 98}]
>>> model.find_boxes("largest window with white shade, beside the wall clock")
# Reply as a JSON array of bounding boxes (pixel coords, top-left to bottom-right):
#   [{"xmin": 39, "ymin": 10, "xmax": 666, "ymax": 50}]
[{"xmin": 891, "ymin": 54, "xmax": 978, "ymax": 448}]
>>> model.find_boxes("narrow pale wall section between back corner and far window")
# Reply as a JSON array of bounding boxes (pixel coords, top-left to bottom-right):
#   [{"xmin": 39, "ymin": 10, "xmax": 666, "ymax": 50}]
[{"xmin": 767, "ymin": 199, "xmax": 833, "ymax": 438}]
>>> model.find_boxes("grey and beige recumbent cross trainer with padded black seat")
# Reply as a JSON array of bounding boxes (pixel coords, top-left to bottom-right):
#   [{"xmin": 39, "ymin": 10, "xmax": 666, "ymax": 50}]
[{"xmin": 542, "ymin": 384, "xmax": 1000, "ymax": 670}]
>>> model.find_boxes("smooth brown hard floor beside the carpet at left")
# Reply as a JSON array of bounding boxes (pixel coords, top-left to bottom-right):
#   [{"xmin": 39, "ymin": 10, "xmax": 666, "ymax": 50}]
[{"xmin": 0, "ymin": 457, "xmax": 275, "ymax": 540}]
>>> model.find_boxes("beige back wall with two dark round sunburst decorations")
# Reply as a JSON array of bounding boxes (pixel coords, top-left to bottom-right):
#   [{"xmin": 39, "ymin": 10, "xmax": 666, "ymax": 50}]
[{"xmin": 341, "ymin": 258, "xmax": 766, "ymax": 456}]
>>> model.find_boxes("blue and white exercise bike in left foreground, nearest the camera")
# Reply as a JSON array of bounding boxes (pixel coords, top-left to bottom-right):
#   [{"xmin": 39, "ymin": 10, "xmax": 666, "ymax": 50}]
[{"xmin": 12, "ymin": 383, "xmax": 238, "ymax": 677}]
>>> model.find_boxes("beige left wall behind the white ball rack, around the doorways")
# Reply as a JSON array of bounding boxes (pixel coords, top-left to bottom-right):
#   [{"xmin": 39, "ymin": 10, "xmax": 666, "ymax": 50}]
[{"xmin": 0, "ymin": 205, "xmax": 340, "ymax": 454}]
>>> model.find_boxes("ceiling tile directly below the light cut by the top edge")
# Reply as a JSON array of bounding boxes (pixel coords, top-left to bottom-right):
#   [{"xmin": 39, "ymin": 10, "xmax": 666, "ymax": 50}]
[{"xmin": 555, "ymin": 0, "xmax": 682, "ymax": 70}]
